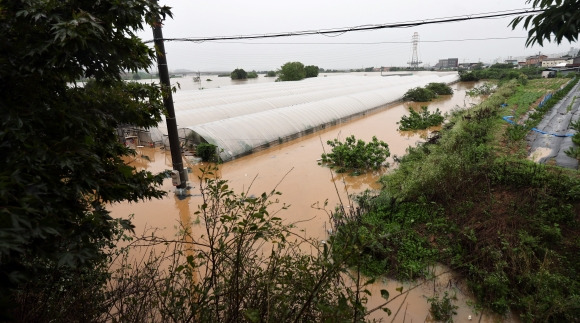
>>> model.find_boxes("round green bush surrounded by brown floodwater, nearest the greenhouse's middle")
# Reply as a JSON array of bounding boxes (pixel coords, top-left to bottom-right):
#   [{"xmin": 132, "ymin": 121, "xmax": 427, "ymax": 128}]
[{"xmin": 322, "ymin": 135, "xmax": 390, "ymax": 174}]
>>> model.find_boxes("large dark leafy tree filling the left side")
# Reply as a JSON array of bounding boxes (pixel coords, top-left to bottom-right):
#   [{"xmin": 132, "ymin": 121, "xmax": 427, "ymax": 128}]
[{"xmin": 0, "ymin": 0, "xmax": 171, "ymax": 321}]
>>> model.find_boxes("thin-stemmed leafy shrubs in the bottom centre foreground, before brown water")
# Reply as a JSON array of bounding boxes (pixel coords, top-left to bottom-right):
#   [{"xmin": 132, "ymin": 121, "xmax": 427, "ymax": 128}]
[{"xmin": 104, "ymin": 170, "xmax": 384, "ymax": 322}]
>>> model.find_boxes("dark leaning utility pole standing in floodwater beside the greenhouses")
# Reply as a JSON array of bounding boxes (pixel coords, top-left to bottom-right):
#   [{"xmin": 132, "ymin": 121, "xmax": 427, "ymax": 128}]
[{"xmin": 153, "ymin": 21, "xmax": 187, "ymax": 191}]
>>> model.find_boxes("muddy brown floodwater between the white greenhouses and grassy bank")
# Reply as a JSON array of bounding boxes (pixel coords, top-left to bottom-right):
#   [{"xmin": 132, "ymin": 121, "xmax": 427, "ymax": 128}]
[{"xmin": 110, "ymin": 83, "xmax": 516, "ymax": 322}]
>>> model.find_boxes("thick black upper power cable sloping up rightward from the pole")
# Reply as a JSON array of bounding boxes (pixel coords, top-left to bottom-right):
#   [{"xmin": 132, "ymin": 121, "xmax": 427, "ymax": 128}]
[{"xmin": 144, "ymin": 9, "xmax": 544, "ymax": 43}]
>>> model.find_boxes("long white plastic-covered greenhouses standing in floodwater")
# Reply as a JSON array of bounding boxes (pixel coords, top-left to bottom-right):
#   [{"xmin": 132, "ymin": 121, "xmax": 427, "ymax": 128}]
[{"xmin": 154, "ymin": 73, "xmax": 459, "ymax": 161}]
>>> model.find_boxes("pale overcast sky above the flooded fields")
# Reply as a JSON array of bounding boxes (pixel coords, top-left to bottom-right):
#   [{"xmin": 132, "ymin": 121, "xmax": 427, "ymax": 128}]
[{"xmin": 139, "ymin": 0, "xmax": 580, "ymax": 71}]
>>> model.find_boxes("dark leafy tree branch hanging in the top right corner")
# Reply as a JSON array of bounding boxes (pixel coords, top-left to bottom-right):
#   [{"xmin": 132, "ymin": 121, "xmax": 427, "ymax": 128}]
[{"xmin": 510, "ymin": 0, "xmax": 580, "ymax": 46}]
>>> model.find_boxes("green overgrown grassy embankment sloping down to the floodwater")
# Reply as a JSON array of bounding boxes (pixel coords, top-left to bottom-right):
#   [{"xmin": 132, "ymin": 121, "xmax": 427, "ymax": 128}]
[{"xmin": 338, "ymin": 79, "xmax": 580, "ymax": 322}]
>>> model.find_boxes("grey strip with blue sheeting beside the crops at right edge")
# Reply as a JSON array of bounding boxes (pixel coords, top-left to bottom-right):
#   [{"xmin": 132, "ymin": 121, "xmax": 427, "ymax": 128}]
[{"xmin": 527, "ymin": 82, "xmax": 580, "ymax": 169}]
